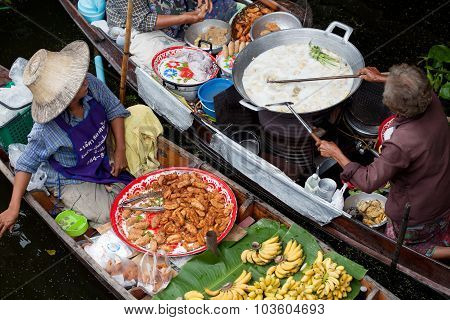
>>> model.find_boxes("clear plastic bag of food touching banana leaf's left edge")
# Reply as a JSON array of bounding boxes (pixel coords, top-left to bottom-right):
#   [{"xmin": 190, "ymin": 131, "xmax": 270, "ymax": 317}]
[{"xmin": 137, "ymin": 250, "xmax": 175, "ymax": 295}]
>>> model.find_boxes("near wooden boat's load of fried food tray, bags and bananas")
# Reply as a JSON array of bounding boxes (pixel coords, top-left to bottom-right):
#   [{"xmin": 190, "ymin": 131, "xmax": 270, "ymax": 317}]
[{"xmin": 0, "ymin": 62, "xmax": 396, "ymax": 300}]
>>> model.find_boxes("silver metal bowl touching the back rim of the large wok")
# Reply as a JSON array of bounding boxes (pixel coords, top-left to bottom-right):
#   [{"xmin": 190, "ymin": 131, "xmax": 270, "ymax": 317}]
[{"xmin": 250, "ymin": 12, "xmax": 303, "ymax": 41}]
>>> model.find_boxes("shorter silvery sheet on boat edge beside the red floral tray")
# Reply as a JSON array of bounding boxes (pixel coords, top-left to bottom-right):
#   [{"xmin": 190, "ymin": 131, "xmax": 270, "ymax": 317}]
[{"xmin": 136, "ymin": 68, "xmax": 194, "ymax": 131}]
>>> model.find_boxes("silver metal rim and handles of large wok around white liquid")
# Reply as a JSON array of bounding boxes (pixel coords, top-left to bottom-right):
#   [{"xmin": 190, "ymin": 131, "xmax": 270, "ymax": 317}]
[{"xmin": 233, "ymin": 21, "xmax": 364, "ymax": 117}]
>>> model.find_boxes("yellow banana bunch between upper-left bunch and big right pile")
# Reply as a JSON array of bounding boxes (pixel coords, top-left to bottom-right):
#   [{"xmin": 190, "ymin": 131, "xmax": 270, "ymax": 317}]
[{"xmin": 267, "ymin": 239, "xmax": 305, "ymax": 279}]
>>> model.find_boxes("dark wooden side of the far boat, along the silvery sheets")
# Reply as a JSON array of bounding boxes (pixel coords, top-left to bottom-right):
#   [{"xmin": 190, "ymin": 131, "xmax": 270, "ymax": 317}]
[{"xmin": 59, "ymin": 0, "xmax": 450, "ymax": 296}]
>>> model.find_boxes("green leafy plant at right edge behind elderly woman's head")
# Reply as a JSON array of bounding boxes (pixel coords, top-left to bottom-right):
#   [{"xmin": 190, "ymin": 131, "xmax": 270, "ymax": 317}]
[{"xmin": 420, "ymin": 44, "xmax": 450, "ymax": 100}]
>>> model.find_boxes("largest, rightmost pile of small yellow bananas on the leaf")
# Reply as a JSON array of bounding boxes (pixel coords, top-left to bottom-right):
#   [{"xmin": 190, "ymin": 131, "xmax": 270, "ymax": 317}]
[{"xmin": 300, "ymin": 250, "xmax": 353, "ymax": 299}]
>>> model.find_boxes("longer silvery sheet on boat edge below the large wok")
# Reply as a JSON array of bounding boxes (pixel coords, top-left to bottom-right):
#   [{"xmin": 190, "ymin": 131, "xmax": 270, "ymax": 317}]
[{"xmin": 210, "ymin": 131, "xmax": 343, "ymax": 225}]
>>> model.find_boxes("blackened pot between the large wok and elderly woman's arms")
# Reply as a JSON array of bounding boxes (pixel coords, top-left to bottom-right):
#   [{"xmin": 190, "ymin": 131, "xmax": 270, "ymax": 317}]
[{"xmin": 347, "ymin": 81, "xmax": 392, "ymax": 126}]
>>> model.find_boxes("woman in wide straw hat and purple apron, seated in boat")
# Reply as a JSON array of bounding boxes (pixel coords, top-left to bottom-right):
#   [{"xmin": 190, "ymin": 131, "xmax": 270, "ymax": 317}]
[{"xmin": 0, "ymin": 41, "xmax": 133, "ymax": 237}]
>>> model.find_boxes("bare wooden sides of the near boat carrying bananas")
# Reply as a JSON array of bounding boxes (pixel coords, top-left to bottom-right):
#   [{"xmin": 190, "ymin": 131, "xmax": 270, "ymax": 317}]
[{"xmin": 0, "ymin": 66, "xmax": 398, "ymax": 300}]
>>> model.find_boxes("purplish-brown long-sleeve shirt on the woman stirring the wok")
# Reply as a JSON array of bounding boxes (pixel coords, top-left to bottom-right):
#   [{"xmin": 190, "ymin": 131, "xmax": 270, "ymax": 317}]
[{"xmin": 341, "ymin": 96, "xmax": 450, "ymax": 226}]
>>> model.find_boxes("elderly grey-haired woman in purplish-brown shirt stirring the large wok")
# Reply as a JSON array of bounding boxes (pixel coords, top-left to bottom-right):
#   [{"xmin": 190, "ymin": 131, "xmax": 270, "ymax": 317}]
[{"xmin": 318, "ymin": 64, "xmax": 450, "ymax": 259}]
